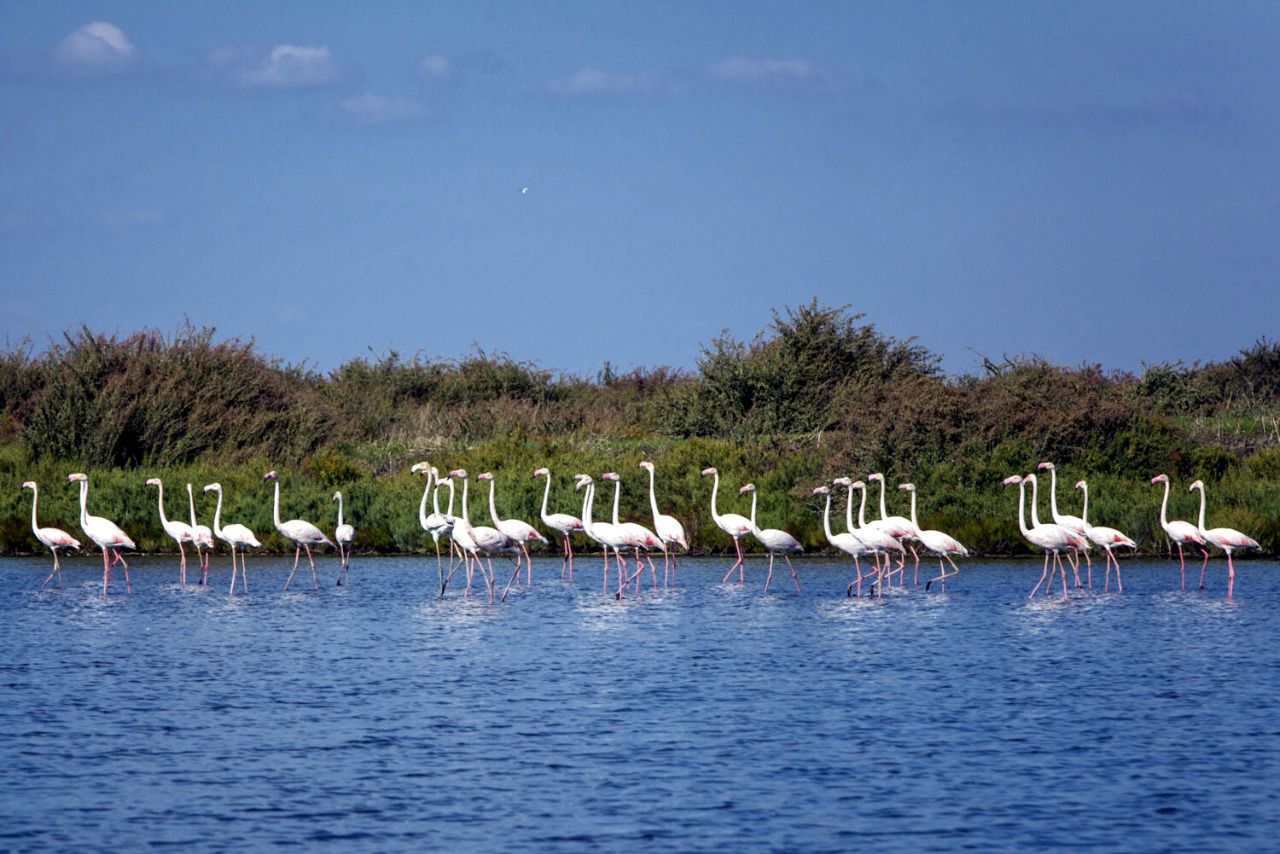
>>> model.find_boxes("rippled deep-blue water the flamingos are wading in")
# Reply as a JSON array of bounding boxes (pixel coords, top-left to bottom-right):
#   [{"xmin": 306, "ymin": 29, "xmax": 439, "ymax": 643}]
[{"xmin": 0, "ymin": 556, "xmax": 1280, "ymax": 851}]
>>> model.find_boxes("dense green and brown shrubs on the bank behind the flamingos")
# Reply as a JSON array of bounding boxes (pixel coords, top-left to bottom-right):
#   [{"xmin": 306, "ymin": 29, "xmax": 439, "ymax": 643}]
[{"xmin": 0, "ymin": 302, "xmax": 1280, "ymax": 553}]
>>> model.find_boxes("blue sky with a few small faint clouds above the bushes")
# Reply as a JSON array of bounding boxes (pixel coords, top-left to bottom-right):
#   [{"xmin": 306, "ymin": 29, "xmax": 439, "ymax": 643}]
[{"xmin": 0, "ymin": 0, "xmax": 1280, "ymax": 375}]
